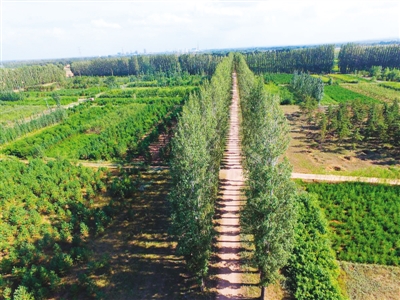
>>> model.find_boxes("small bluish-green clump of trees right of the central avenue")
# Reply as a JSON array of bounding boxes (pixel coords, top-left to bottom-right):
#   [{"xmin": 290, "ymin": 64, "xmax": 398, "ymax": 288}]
[{"xmin": 291, "ymin": 71, "xmax": 324, "ymax": 102}]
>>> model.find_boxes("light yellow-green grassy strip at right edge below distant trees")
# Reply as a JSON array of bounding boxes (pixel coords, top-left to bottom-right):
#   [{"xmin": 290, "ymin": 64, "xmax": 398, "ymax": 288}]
[{"xmin": 341, "ymin": 82, "xmax": 400, "ymax": 102}]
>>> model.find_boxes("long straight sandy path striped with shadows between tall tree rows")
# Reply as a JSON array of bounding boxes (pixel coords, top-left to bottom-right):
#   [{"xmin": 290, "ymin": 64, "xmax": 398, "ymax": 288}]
[{"xmin": 215, "ymin": 73, "xmax": 244, "ymax": 299}]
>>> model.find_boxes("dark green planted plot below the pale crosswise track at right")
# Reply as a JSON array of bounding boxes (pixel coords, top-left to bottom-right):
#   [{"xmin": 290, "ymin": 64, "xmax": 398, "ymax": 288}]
[{"xmin": 302, "ymin": 182, "xmax": 400, "ymax": 265}]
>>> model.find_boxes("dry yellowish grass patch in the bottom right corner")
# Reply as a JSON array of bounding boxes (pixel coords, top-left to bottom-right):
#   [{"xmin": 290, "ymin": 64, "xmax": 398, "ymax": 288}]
[{"xmin": 339, "ymin": 261, "xmax": 400, "ymax": 300}]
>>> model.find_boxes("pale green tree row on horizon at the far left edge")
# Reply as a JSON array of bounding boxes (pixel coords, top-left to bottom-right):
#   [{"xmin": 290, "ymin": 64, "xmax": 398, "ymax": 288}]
[{"xmin": 0, "ymin": 64, "xmax": 65, "ymax": 91}]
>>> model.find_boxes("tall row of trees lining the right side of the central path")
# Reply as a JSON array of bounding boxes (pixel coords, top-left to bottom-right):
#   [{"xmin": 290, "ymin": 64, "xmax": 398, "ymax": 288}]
[{"xmin": 235, "ymin": 55, "xmax": 296, "ymax": 297}]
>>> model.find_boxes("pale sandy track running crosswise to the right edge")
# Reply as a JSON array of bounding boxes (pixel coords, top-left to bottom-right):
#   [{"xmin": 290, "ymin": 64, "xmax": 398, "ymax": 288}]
[{"xmin": 291, "ymin": 173, "xmax": 400, "ymax": 185}]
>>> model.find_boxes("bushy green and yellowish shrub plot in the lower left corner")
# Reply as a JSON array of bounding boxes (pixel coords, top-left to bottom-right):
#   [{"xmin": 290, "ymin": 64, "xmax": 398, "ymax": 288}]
[{"xmin": 0, "ymin": 160, "xmax": 112, "ymax": 299}]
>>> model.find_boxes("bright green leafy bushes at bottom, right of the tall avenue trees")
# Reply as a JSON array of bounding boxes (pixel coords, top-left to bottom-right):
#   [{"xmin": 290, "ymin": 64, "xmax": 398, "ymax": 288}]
[{"xmin": 284, "ymin": 193, "xmax": 343, "ymax": 300}]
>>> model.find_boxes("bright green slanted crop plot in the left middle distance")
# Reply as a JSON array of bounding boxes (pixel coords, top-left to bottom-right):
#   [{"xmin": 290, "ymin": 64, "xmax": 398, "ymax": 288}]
[{"xmin": 4, "ymin": 98, "xmax": 182, "ymax": 160}]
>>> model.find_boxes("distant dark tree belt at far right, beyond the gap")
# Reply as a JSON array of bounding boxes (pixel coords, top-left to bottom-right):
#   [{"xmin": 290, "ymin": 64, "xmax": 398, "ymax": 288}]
[{"xmin": 338, "ymin": 43, "xmax": 400, "ymax": 73}]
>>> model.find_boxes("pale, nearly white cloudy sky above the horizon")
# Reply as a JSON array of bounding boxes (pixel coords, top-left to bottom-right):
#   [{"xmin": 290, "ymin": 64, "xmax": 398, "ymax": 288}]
[{"xmin": 0, "ymin": 0, "xmax": 400, "ymax": 60}]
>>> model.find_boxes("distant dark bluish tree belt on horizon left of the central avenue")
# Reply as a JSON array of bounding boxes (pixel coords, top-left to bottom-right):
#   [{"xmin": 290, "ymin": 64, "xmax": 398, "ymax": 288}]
[{"xmin": 71, "ymin": 54, "xmax": 222, "ymax": 76}]
